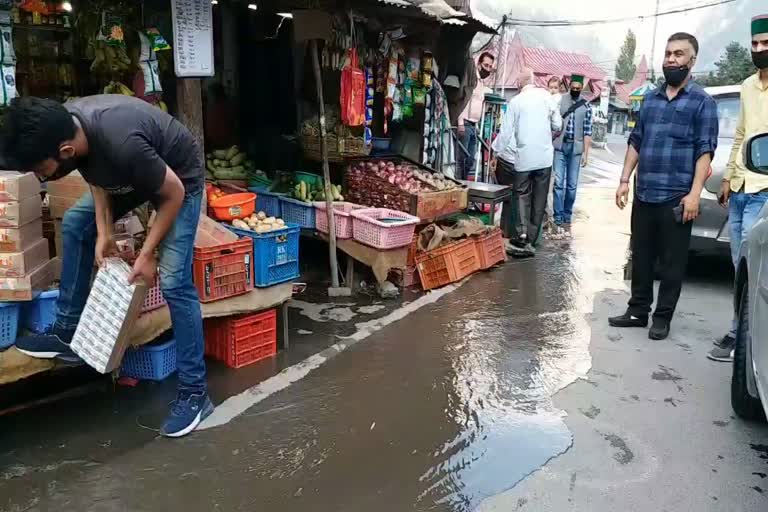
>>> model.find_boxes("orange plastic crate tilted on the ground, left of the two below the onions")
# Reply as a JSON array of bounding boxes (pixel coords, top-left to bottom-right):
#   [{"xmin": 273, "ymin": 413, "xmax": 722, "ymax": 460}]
[{"xmin": 416, "ymin": 238, "xmax": 480, "ymax": 290}]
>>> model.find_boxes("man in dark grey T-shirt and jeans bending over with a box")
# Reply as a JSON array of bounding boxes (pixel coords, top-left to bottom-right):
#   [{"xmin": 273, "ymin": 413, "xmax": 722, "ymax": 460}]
[{"xmin": 4, "ymin": 95, "xmax": 213, "ymax": 437}]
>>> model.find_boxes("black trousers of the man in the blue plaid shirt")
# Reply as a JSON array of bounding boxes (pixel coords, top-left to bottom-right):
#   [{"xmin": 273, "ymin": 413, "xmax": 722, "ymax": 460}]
[{"xmin": 629, "ymin": 198, "xmax": 693, "ymax": 321}]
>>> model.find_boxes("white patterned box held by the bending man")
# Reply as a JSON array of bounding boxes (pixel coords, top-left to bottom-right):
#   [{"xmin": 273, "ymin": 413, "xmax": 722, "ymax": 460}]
[{"xmin": 70, "ymin": 258, "xmax": 147, "ymax": 373}]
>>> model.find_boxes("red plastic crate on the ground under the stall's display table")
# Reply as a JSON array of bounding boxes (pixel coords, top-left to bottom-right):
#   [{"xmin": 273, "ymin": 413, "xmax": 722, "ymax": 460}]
[{"xmin": 205, "ymin": 309, "xmax": 277, "ymax": 368}]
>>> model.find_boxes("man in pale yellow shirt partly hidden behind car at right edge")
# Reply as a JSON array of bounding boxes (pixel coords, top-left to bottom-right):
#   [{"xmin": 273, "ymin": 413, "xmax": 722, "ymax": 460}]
[{"xmin": 707, "ymin": 15, "xmax": 768, "ymax": 362}]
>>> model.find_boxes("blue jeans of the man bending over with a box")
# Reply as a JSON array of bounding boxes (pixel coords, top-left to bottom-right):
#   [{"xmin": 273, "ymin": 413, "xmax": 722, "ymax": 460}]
[{"xmin": 55, "ymin": 190, "xmax": 206, "ymax": 394}]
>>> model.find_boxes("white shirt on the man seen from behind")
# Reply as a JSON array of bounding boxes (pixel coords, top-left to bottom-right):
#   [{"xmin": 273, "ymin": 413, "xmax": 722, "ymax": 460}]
[{"xmin": 493, "ymin": 85, "xmax": 563, "ymax": 172}]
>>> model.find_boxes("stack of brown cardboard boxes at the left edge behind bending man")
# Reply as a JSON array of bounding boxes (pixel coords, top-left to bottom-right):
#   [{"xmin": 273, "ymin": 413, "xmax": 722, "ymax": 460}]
[{"xmin": 0, "ymin": 171, "xmax": 59, "ymax": 302}]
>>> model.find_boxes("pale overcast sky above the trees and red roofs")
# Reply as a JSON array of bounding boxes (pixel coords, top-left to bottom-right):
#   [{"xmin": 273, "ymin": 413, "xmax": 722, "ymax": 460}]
[{"xmin": 472, "ymin": 0, "xmax": 768, "ymax": 75}]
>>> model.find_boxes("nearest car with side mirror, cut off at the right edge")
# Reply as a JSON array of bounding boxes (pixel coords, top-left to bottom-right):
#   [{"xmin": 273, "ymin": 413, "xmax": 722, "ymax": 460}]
[{"xmin": 731, "ymin": 133, "xmax": 768, "ymax": 420}]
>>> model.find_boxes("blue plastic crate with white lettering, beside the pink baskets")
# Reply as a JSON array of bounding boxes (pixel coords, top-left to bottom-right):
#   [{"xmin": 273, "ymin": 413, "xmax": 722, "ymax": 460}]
[{"xmin": 227, "ymin": 224, "xmax": 301, "ymax": 288}]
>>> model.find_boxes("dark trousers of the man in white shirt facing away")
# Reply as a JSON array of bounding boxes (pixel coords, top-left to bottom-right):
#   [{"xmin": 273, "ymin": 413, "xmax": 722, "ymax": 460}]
[{"xmin": 496, "ymin": 158, "xmax": 552, "ymax": 243}]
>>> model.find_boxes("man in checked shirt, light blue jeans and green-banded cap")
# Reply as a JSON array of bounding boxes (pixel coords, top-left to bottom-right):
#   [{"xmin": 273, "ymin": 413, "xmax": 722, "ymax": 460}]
[{"xmin": 554, "ymin": 75, "xmax": 592, "ymax": 236}]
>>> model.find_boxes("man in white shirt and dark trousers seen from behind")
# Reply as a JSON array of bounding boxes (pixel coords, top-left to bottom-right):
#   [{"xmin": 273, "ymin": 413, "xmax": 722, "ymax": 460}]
[{"xmin": 493, "ymin": 69, "xmax": 562, "ymax": 257}]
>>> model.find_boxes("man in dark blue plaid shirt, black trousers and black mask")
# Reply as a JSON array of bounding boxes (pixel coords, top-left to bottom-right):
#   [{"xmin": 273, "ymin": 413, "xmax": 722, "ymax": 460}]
[{"xmin": 608, "ymin": 33, "xmax": 718, "ymax": 340}]
